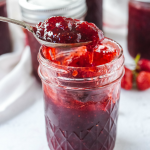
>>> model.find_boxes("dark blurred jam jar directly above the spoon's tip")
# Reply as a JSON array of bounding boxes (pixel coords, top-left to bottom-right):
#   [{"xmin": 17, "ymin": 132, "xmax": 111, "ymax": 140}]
[{"xmin": 85, "ymin": 0, "xmax": 103, "ymax": 30}]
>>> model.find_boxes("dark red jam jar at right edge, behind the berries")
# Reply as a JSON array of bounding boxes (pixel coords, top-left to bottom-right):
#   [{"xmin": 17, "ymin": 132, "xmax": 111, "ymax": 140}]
[{"xmin": 128, "ymin": 0, "xmax": 150, "ymax": 60}]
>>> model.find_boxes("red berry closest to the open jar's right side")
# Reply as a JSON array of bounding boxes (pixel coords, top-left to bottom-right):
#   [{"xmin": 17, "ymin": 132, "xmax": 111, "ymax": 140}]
[{"xmin": 121, "ymin": 67, "xmax": 133, "ymax": 90}]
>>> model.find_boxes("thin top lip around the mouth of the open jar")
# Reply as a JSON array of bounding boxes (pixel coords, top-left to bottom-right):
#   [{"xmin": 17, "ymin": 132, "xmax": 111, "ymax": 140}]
[{"xmin": 38, "ymin": 37, "xmax": 123, "ymax": 69}]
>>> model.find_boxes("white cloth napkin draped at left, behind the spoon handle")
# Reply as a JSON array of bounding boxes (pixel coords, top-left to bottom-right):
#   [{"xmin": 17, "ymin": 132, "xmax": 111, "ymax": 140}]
[{"xmin": 0, "ymin": 0, "xmax": 42, "ymax": 122}]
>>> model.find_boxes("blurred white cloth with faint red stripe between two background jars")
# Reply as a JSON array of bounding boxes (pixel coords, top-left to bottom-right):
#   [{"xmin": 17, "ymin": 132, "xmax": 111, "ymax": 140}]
[{"xmin": 103, "ymin": 0, "xmax": 129, "ymax": 38}]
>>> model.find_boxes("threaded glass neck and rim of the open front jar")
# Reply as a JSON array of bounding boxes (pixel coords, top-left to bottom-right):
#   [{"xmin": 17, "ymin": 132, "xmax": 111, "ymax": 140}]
[{"xmin": 38, "ymin": 38, "xmax": 124, "ymax": 90}]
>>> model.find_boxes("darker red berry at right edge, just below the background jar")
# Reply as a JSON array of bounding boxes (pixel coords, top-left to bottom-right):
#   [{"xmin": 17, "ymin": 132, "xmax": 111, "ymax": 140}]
[{"xmin": 137, "ymin": 59, "xmax": 150, "ymax": 72}]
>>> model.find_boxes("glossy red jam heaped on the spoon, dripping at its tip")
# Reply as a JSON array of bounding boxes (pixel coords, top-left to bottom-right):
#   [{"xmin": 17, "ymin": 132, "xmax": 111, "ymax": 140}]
[{"xmin": 34, "ymin": 17, "xmax": 104, "ymax": 51}]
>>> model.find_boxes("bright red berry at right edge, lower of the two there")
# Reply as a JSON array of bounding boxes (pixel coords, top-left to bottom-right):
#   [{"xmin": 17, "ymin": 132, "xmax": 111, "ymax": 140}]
[{"xmin": 136, "ymin": 71, "xmax": 150, "ymax": 91}]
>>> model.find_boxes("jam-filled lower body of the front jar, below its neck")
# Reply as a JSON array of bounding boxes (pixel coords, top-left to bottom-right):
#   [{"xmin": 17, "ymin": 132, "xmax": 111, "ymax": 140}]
[{"xmin": 43, "ymin": 83, "xmax": 120, "ymax": 150}]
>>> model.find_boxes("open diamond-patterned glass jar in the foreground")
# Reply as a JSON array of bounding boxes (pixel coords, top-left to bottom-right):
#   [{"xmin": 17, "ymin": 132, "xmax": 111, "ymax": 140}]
[{"xmin": 38, "ymin": 38, "xmax": 124, "ymax": 150}]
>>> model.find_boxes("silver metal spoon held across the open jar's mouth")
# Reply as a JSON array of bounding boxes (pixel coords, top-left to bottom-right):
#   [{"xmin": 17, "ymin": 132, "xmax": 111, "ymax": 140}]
[{"xmin": 0, "ymin": 16, "xmax": 91, "ymax": 48}]
